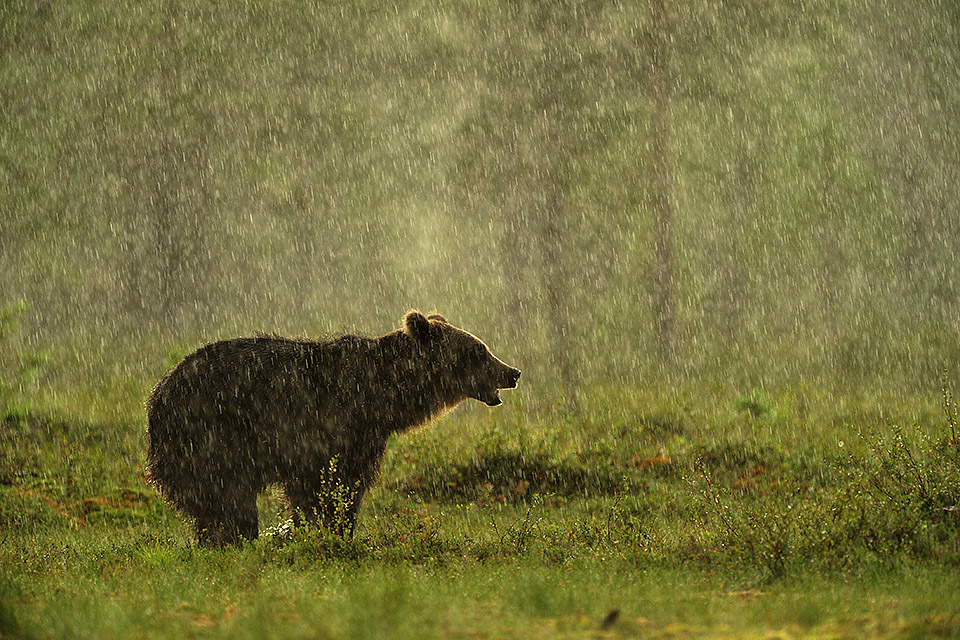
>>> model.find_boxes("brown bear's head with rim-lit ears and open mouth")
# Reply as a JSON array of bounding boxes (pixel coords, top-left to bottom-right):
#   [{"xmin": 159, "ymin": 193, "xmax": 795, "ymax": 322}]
[{"xmin": 403, "ymin": 311, "xmax": 520, "ymax": 407}]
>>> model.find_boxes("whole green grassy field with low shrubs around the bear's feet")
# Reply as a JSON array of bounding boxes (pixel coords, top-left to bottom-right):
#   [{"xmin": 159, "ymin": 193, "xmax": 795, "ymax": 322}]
[{"xmin": 0, "ymin": 386, "xmax": 960, "ymax": 638}]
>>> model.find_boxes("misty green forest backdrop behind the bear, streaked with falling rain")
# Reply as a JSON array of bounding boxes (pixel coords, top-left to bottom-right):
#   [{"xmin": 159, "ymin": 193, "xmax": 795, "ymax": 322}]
[{"xmin": 0, "ymin": 0, "xmax": 960, "ymax": 410}]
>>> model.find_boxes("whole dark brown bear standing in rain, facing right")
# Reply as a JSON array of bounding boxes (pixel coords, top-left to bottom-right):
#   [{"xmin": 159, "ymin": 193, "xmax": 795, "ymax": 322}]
[{"xmin": 147, "ymin": 311, "xmax": 520, "ymax": 547}]
